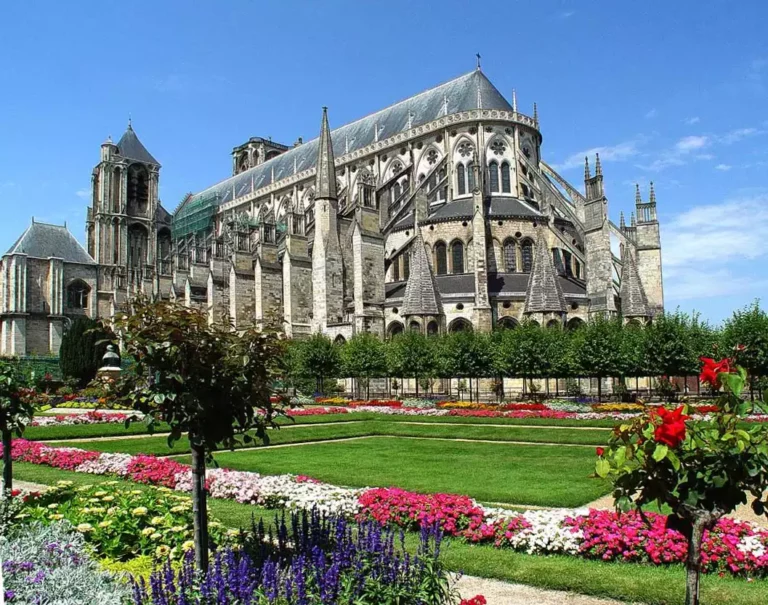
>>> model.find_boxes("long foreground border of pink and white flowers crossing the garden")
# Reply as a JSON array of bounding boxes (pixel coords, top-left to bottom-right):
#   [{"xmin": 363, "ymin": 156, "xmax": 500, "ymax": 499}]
[{"xmin": 6, "ymin": 436, "xmax": 768, "ymax": 577}]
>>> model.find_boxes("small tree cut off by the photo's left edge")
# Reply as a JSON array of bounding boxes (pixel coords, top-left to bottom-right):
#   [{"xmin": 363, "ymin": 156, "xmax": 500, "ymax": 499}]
[{"xmin": 0, "ymin": 360, "xmax": 35, "ymax": 491}]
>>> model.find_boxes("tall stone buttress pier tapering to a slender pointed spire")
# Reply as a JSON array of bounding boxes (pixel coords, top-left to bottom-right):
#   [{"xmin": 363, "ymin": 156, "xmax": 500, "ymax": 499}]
[{"xmin": 312, "ymin": 107, "xmax": 344, "ymax": 332}]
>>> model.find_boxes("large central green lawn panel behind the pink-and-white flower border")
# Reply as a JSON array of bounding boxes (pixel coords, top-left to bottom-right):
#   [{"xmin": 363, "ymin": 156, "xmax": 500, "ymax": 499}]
[{"xmin": 206, "ymin": 437, "xmax": 609, "ymax": 507}]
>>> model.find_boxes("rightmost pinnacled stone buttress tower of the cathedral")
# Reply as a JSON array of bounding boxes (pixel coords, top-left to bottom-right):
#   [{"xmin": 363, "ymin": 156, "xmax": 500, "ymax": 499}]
[{"xmin": 635, "ymin": 182, "xmax": 664, "ymax": 315}]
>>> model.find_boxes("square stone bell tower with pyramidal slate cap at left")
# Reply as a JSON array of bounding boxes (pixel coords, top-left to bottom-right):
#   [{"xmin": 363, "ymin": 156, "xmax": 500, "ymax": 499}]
[{"xmin": 86, "ymin": 121, "xmax": 160, "ymax": 316}]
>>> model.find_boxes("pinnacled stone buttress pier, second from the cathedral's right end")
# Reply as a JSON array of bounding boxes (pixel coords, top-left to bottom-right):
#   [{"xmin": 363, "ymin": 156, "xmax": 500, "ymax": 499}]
[{"xmin": 584, "ymin": 155, "xmax": 616, "ymax": 314}]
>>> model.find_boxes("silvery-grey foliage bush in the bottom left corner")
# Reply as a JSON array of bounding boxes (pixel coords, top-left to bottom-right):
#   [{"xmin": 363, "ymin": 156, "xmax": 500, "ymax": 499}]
[{"xmin": 0, "ymin": 523, "xmax": 128, "ymax": 605}]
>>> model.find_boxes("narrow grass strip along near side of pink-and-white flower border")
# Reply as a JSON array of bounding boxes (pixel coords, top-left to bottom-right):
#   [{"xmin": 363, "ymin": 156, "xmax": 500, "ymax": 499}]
[{"xmin": 14, "ymin": 462, "xmax": 768, "ymax": 605}]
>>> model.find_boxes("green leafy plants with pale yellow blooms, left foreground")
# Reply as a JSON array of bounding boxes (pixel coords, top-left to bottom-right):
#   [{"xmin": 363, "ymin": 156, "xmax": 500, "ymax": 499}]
[{"xmin": 24, "ymin": 481, "xmax": 227, "ymax": 561}]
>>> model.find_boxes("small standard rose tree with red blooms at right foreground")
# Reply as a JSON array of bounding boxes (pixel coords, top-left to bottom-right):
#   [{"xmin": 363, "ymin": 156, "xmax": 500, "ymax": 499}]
[{"xmin": 596, "ymin": 358, "xmax": 768, "ymax": 605}]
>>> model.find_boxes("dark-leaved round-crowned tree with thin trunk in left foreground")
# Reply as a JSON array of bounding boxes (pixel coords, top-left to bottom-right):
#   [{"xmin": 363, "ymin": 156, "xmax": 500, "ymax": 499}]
[{"xmin": 114, "ymin": 298, "xmax": 282, "ymax": 570}]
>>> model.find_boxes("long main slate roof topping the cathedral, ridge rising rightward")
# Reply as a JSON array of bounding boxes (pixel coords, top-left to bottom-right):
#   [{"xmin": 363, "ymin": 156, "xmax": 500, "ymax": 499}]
[{"xmin": 177, "ymin": 70, "xmax": 512, "ymax": 212}]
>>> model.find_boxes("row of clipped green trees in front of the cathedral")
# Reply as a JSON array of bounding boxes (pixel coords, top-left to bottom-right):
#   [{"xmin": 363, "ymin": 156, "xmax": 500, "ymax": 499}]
[{"xmin": 284, "ymin": 302, "xmax": 768, "ymax": 397}]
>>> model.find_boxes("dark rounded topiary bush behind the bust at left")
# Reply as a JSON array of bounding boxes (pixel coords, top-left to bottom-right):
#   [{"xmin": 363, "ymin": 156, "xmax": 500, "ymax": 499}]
[{"xmin": 59, "ymin": 317, "xmax": 112, "ymax": 387}]
